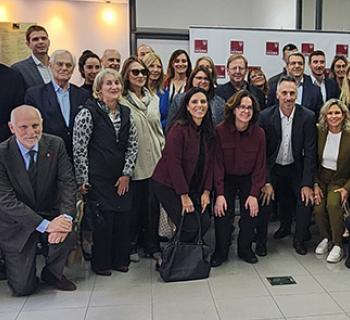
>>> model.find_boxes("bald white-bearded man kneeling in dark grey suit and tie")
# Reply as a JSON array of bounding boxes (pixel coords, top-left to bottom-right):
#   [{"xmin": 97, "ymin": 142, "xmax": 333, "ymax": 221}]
[{"xmin": 0, "ymin": 105, "xmax": 76, "ymax": 296}]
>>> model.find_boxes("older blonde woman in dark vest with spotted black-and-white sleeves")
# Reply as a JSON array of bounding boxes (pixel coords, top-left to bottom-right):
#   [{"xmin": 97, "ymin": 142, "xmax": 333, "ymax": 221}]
[{"xmin": 73, "ymin": 68, "xmax": 138, "ymax": 276}]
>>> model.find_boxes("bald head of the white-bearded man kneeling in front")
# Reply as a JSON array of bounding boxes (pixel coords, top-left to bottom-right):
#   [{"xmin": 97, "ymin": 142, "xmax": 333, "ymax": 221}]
[{"xmin": 9, "ymin": 105, "xmax": 43, "ymax": 150}]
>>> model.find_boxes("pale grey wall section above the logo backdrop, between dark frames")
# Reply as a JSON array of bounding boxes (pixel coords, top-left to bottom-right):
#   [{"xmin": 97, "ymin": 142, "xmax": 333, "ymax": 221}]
[{"xmin": 136, "ymin": 0, "xmax": 296, "ymax": 29}]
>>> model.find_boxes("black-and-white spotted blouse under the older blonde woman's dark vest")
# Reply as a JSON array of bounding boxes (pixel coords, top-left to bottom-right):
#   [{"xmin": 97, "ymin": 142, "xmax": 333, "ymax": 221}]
[{"xmin": 73, "ymin": 101, "xmax": 138, "ymax": 185}]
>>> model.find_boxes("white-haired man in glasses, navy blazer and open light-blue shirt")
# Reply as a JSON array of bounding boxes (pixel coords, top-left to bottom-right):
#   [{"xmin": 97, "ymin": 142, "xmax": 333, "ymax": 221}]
[{"xmin": 24, "ymin": 50, "xmax": 89, "ymax": 158}]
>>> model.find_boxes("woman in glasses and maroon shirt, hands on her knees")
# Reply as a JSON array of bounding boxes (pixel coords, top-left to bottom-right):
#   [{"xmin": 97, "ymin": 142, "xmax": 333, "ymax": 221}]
[{"xmin": 212, "ymin": 90, "xmax": 266, "ymax": 267}]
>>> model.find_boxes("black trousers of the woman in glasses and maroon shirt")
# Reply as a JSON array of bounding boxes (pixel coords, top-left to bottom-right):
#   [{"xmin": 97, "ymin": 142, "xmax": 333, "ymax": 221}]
[{"xmin": 214, "ymin": 175, "xmax": 256, "ymax": 260}]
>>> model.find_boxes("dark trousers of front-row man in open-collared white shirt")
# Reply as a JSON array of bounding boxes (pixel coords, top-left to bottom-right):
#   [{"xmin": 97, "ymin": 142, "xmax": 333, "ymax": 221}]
[{"xmin": 271, "ymin": 164, "xmax": 311, "ymax": 242}]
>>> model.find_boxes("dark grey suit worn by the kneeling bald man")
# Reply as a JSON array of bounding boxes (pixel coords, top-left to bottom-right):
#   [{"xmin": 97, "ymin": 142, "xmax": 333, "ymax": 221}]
[{"xmin": 0, "ymin": 134, "xmax": 76, "ymax": 295}]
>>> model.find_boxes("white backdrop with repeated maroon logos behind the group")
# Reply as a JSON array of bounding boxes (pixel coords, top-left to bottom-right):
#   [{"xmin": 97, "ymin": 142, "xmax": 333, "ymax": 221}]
[{"xmin": 189, "ymin": 26, "xmax": 350, "ymax": 83}]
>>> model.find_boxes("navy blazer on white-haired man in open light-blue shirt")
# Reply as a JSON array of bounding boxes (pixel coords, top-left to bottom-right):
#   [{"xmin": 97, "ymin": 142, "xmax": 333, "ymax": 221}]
[{"xmin": 24, "ymin": 82, "xmax": 89, "ymax": 158}]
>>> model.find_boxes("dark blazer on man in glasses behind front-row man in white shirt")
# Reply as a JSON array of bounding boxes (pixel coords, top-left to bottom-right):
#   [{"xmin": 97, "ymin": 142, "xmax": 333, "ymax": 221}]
[{"xmin": 266, "ymin": 74, "xmax": 323, "ymax": 119}]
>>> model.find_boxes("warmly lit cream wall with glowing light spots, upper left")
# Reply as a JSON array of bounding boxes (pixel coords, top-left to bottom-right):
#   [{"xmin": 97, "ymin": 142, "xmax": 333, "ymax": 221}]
[{"xmin": 0, "ymin": 0, "xmax": 129, "ymax": 84}]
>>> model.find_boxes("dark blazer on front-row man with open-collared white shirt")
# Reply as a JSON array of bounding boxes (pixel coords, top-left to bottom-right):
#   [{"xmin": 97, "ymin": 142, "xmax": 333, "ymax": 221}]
[{"xmin": 259, "ymin": 105, "xmax": 316, "ymax": 187}]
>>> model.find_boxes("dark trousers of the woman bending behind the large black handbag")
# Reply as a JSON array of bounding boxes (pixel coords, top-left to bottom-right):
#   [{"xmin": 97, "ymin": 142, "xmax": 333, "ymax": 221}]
[{"xmin": 151, "ymin": 180, "xmax": 210, "ymax": 242}]
